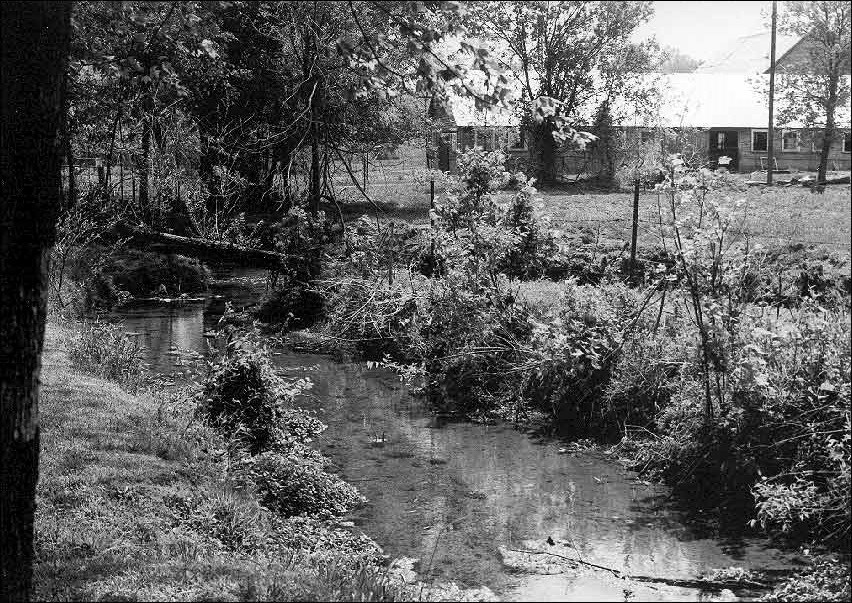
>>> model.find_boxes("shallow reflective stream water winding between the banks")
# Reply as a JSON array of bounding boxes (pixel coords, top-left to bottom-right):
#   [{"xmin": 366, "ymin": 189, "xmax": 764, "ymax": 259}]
[{"xmin": 105, "ymin": 271, "xmax": 792, "ymax": 601}]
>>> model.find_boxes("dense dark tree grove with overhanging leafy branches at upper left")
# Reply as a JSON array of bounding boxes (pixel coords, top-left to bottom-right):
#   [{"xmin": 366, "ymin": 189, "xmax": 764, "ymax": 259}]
[{"xmin": 66, "ymin": 1, "xmax": 504, "ymax": 237}]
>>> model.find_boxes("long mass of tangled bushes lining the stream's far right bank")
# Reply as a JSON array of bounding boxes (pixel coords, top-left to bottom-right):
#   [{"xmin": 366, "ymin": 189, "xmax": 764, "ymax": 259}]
[{"xmin": 314, "ymin": 151, "xmax": 850, "ymax": 572}]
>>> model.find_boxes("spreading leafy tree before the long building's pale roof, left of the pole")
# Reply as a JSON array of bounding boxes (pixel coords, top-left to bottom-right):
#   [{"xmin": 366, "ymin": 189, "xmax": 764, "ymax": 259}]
[{"xmin": 468, "ymin": 1, "xmax": 653, "ymax": 182}]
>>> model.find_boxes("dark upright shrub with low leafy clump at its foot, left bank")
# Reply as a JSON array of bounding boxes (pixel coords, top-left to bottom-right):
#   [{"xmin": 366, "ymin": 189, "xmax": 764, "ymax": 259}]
[{"xmin": 198, "ymin": 312, "xmax": 364, "ymax": 519}]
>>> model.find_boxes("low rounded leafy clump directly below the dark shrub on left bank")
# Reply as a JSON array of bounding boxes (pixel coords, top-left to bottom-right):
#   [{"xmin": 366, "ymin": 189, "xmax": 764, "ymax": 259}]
[{"xmin": 234, "ymin": 444, "xmax": 364, "ymax": 518}]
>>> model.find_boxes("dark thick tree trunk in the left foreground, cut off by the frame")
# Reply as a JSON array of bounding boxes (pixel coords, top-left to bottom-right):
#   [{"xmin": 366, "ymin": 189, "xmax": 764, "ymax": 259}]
[{"xmin": 0, "ymin": 1, "xmax": 71, "ymax": 601}]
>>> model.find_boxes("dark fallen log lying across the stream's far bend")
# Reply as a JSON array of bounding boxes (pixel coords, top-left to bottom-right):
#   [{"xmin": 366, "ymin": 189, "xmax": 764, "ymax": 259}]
[{"xmin": 115, "ymin": 224, "xmax": 287, "ymax": 268}]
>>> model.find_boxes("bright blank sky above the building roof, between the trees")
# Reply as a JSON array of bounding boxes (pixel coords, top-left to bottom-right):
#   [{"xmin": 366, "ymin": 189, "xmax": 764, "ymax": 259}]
[{"xmin": 634, "ymin": 0, "xmax": 772, "ymax": 60}]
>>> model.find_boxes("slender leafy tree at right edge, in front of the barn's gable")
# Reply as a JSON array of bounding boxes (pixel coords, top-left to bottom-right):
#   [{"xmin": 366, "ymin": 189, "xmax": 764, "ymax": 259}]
[{"xmin": 777, "ymin": 0, "xmax": 852, "ymax": 182}]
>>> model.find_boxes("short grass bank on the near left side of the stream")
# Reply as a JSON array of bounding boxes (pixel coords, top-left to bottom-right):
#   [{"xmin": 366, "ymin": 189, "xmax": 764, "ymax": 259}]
[{"xmin": 34, "ymin": 324, "xmax": 402, "ymax": 601}]
